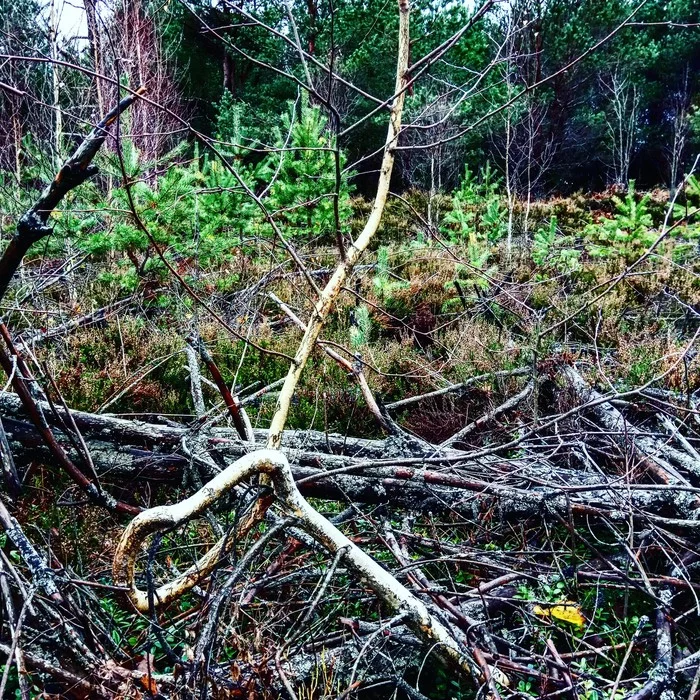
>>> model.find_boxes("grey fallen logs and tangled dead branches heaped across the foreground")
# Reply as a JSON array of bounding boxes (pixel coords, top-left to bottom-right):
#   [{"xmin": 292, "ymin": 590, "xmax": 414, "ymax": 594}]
[{"xmin": 0, "ymin": 358, "xmax": 700, "ymax": 697}]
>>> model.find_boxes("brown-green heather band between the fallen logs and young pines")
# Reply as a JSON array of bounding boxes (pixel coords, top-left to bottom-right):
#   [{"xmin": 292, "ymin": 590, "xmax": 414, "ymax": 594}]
[{"xmin": 30, "ymin": 219, "xmax": 700, "ymax": 439}]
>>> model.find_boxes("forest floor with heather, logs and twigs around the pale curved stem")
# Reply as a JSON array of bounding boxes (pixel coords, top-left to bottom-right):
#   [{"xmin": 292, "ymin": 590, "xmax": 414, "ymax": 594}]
[{"xmin": 0, "ymin": 187, "xmax": 700, "ymax": 700}]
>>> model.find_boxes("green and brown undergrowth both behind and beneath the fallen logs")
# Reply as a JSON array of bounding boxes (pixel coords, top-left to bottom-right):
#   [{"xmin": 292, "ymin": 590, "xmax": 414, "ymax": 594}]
[{"xmin": 8, "ymin": 173, "xmax": 700, "ymax": 700}]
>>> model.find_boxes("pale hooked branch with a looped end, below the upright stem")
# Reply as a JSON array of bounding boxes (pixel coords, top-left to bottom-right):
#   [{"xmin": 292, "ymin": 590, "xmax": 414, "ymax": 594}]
[{"xmin": 114, "ymin": 449, "xmax": 470, "ymax": 672}]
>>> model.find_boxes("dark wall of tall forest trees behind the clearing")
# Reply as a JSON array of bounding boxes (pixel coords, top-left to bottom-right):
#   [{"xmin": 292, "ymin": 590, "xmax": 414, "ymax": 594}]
[{"xmin": 0, "ymin": 0, "xmax": 700, "ymax": 197}]
